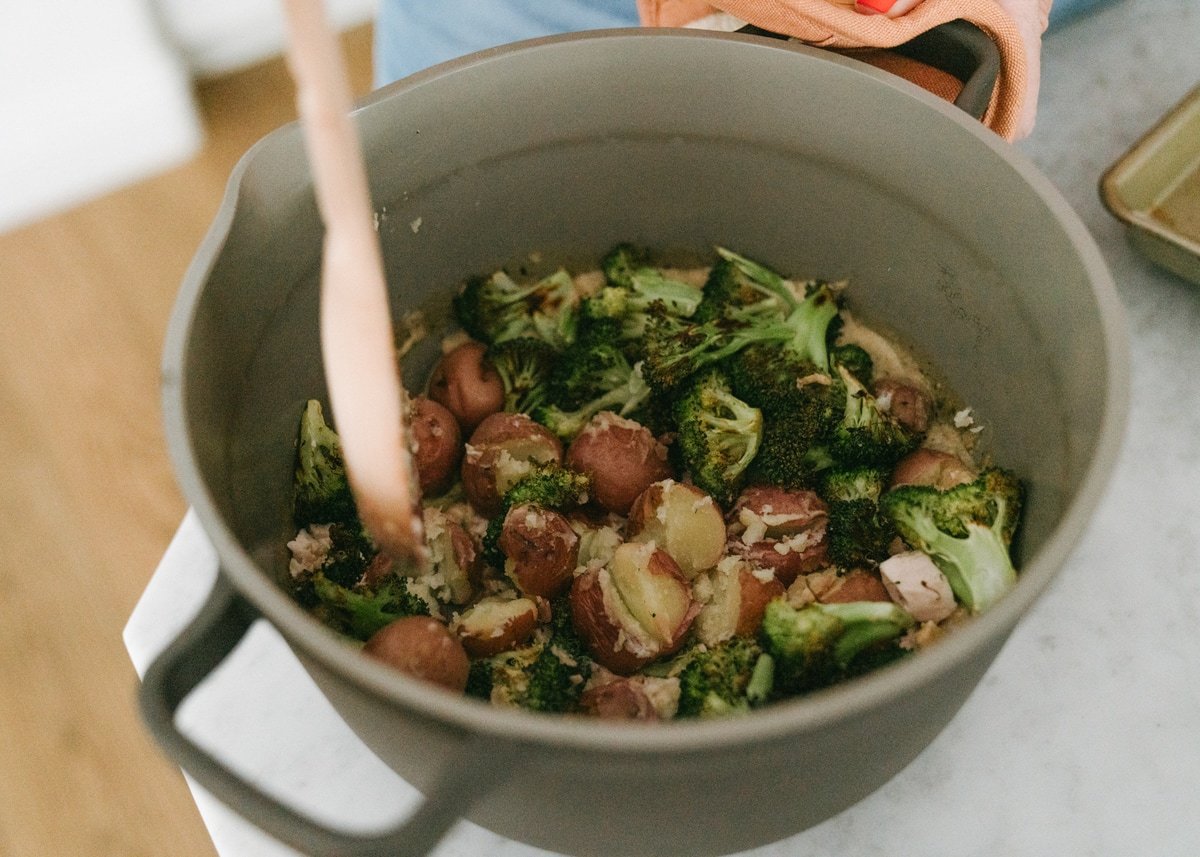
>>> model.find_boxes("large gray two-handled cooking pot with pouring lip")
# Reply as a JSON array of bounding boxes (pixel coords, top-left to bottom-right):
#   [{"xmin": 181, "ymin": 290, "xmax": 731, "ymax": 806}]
[{"xmin": 143, "ymin": 31, "xmax": 1128, "ymax": 857}]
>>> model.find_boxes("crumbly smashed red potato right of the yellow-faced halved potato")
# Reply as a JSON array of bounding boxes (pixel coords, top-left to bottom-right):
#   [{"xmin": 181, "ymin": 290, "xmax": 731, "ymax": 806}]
[{"xmin": 727, "ymin": 486, "xmax": 829, "ymax": 587}]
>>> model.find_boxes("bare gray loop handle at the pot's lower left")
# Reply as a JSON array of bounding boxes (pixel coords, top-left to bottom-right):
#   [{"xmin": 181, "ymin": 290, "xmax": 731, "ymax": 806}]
[{"xmin": 138, "ymin": 574, "xmax": 511, "ymax": 857}]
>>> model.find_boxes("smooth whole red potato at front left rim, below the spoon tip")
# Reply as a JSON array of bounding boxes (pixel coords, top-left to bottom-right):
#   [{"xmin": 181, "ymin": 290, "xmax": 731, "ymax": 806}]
[{"xmin": 362, "ymin": 616, "xmax": 470, "ymax": 693}]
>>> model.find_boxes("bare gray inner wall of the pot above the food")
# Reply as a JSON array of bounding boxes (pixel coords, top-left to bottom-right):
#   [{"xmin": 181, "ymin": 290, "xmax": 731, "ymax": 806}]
[{"xmin": 174, "ymin": 31, "xmax": 1111, "ymax": 652}]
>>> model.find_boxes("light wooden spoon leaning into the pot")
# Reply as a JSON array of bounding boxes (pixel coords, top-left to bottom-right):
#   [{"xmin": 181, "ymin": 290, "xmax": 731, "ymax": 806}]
[{"xmin": 283, "ymin": 0, "xmax": 425, "ymax": 562}]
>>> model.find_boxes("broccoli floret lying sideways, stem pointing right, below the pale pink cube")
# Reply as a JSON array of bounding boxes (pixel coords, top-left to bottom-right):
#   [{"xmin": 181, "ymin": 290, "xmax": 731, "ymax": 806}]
[{"xmin": 760, "ymin": 598, "xmax": 914, "ymax": 696}]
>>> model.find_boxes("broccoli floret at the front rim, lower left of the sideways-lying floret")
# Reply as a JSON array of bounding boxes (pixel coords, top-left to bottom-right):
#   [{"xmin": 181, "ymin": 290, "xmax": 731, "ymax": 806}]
[{"xmin": 678, "ymin": 637, "xmax": 774, "ymax": 718}]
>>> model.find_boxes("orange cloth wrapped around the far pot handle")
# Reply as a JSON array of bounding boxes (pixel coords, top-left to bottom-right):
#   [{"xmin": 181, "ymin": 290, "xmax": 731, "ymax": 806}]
[{"xmin": 637, "ymin": 0, "xmax": 1050, "ymax": 139}]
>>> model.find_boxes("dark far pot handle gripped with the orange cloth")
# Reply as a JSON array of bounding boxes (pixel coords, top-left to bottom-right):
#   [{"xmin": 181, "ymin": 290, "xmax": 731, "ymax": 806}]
[{"xmin": 738, "ymin": 19, "xmax": 1000, "ymax": 120}]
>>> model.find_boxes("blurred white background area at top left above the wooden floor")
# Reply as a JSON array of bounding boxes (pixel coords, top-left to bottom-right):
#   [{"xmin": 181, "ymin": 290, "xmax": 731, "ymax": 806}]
[{"xmin": 0, "ymin": 0, "xmax": 374, "ymax": 232}]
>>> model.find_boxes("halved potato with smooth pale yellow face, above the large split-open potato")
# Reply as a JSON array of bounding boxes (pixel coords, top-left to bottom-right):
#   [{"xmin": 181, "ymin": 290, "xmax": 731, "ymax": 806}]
[{"xmin": 626, "ymin": 479, "xmax": 725, "ymax": 580}]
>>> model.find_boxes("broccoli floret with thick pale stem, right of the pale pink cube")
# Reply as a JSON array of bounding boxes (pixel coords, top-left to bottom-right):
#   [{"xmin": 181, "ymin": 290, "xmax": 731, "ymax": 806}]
[{"xmin": 880, "ymin": 467, "xmax": 1024, "ymax": 612}]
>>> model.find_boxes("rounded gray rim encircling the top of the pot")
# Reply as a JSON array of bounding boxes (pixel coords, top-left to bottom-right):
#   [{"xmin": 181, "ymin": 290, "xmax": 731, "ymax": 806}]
[{"xmin": 162, "ymin": 29, "xmax": 1130, "ymax": 755}]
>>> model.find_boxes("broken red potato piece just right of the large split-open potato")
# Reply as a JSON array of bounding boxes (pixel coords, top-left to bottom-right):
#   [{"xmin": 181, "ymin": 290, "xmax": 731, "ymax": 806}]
[{"xmin": 694, "ymin": 557, "xmax": 787, "ymax": 646}]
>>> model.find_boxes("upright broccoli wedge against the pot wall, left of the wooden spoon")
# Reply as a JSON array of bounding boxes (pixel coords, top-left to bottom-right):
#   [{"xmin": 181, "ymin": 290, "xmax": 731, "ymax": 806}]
[{"xmin": 292, "ymin": 398, "xmax": 358, "ymax": 527}]
